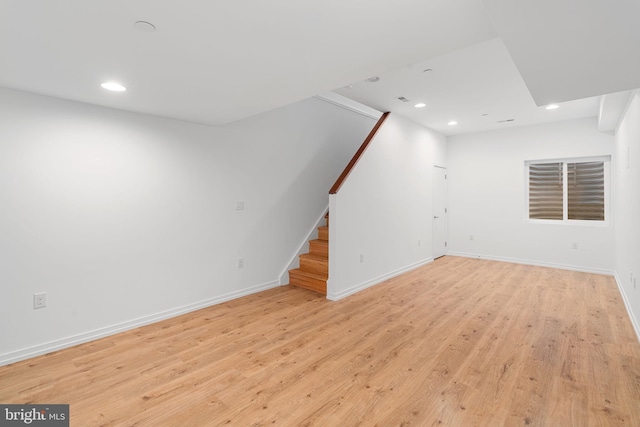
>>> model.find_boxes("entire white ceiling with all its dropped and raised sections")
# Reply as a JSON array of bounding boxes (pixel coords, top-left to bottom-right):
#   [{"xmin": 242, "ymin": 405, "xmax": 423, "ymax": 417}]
[{"xmin": 0, "ymin": 0, "xmax": 640, "ymax": 134}]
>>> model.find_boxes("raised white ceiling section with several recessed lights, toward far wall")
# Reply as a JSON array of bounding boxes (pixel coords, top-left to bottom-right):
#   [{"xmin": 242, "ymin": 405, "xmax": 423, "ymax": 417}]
[{"xmin": 336, "ymin": 38, "xmax": 600, "ymax": 135}]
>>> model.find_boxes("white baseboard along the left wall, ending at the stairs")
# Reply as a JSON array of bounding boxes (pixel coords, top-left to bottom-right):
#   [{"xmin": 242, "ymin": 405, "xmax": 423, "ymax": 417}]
[{"xmin": 0, "ymin": 280, "xmax": 280, "ymax": 366}]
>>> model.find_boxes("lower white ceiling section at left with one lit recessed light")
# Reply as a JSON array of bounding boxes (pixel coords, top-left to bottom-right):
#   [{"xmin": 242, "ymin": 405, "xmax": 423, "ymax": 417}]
[{"xmin": 0, "ymin": 0, "xmax": 496, "ymax": 125}]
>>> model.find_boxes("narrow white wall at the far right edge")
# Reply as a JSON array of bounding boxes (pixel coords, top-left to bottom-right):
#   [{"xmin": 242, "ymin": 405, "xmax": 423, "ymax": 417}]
[{"xmin": 614, "ymin": 91, "xmax": 640, "ymax": 338}]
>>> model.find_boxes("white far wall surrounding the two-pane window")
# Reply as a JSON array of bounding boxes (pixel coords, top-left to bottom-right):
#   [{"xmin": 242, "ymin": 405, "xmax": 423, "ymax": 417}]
[{"xmin": 447, "ymin": 118, "xmax": 615, "ymax": 273}]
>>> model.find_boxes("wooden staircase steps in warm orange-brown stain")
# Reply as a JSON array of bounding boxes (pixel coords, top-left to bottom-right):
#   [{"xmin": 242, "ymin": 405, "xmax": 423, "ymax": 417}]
[{"xmin": 289, "ymin": 213, "xmax": 329, "ymax": 295}]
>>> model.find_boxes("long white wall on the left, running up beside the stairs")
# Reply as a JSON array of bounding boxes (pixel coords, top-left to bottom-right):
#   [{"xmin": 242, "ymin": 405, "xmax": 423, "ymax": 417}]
[{"xmin": 0, "ymin": 89, "xmax": 375, "ymax": 364}]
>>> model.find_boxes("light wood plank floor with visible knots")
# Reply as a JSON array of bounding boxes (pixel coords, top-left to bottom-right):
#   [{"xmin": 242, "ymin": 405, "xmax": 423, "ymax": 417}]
[{"xmin": 0, "ymin": 257, "xmax": 640, "ymax": 427}]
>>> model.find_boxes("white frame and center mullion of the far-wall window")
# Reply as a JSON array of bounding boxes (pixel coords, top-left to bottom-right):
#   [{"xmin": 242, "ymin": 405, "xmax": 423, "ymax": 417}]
[{"xmin": 524, "ymin": 155, "xmax": 611, "ymax": 227}]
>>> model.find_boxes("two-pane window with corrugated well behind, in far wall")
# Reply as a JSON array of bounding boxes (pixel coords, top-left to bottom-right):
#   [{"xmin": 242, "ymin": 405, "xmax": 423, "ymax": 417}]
[{"xmin": 526, "ymin": 157, "xmax": 610, "ymax": 223}]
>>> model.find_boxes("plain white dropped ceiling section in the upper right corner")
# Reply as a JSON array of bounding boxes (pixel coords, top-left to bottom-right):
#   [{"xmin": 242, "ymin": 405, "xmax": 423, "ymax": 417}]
[{"xmin": 483, "ymin": 0, "xmax": 640, "ymax": 105}]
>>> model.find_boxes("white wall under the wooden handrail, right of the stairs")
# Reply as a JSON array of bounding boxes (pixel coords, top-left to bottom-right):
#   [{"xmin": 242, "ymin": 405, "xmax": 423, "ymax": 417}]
[{"xmin": 327, "ymin": 114, "xmax": 446, "ymax": 300}]
